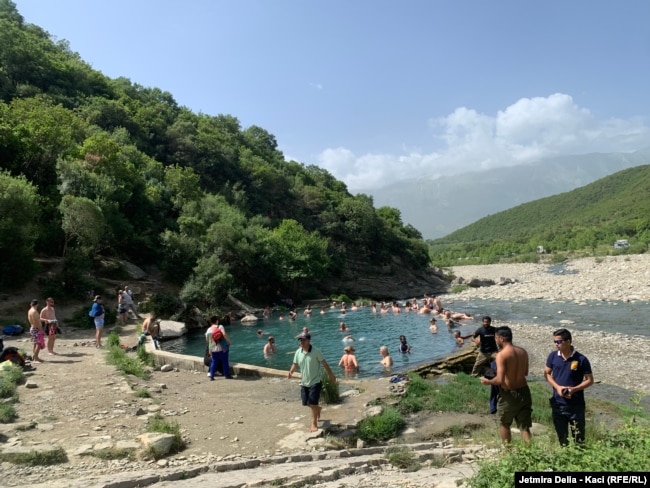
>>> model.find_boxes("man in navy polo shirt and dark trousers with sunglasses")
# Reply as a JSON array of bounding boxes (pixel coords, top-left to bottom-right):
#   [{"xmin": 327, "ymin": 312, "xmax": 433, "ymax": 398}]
[{"xmin": 544, "ymin": 329, "xmax": 594, "ymax": 446}]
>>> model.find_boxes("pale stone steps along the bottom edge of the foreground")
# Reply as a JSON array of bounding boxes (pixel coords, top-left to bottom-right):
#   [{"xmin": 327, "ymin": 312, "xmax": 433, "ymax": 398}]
[{"xmin": 20, "ymin": 442, "xmax": 483, "ymax": 488}]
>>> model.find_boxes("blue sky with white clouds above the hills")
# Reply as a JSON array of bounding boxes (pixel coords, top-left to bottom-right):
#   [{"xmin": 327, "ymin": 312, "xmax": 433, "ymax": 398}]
[{"xmin": 14, "ymin": 0, "xmax": 650, "ymax": 193}]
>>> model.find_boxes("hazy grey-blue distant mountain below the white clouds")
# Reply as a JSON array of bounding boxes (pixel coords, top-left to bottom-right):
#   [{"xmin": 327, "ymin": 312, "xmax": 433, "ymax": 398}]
[{"xmin": 366, "ymin": 148, "xmax": 650, "ymax": 239}]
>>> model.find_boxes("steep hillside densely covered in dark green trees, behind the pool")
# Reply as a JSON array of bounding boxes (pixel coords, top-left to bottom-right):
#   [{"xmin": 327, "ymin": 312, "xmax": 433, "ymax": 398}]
[{"xmin": 0, "ymin": 0, "xmax": 436, "ymax": 306}]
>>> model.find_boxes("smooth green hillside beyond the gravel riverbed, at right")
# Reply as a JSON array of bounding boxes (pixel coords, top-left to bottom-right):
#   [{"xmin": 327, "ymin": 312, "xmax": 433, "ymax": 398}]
[{"xmin": 429, "ymin": 165, "xmax": 650, "ymax": 266}]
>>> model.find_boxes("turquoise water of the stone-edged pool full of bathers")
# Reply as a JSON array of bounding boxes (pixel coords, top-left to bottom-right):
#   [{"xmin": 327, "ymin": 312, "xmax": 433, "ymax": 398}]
[{"xmin": 162, "ymin": 307, "xmax": 466, "ymax": 377}]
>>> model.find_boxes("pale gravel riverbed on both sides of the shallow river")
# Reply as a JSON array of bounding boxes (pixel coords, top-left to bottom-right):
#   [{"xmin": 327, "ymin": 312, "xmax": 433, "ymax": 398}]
[{"xmin": 453, "ymin": 254, "xmax": 650, "ymax": 394}]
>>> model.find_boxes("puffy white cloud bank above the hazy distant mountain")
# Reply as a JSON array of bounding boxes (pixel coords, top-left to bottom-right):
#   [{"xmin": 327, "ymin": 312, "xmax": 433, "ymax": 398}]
[{"xmin": 318, "ymin": 93, "xmax": 650, "ymax": 192}]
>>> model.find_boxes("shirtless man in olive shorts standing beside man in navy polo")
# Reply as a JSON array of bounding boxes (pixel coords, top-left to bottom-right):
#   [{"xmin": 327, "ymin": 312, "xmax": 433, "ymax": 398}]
[{"xmin": 481, "ymin": 327, "xmax": 533, "ymax": 444}]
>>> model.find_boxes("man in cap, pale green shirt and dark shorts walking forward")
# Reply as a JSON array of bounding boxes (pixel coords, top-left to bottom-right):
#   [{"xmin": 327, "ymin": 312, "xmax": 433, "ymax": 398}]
[{"xmin": 289, "ymin": 332, "xmax": 336, "ymax": 432}]
